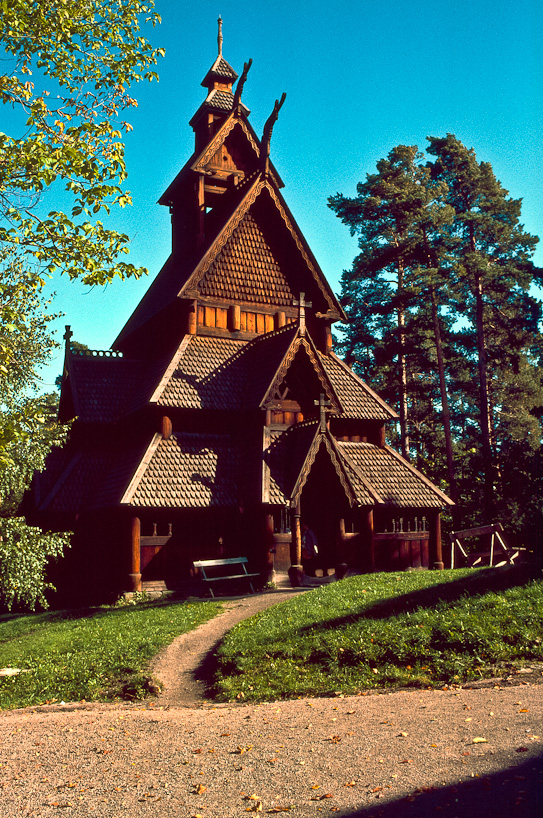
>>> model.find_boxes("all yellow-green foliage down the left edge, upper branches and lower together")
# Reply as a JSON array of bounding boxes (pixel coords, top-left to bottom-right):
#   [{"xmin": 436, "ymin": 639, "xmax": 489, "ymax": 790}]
[{"xmin": 0, "ymin": 0, "xmax": 164, "ymax": 608}]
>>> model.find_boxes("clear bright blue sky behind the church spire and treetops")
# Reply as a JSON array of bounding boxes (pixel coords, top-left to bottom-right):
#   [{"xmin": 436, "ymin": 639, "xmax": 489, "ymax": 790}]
[{"xmin": 30, "ymin": 0, "xmax": 543, "ymax": 389}]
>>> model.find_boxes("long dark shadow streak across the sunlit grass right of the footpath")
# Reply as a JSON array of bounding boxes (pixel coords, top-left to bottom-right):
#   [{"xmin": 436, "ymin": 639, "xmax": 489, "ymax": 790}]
[{"xmin": 300, "ymin": 564, "xmax": 541, "ymax": 633}]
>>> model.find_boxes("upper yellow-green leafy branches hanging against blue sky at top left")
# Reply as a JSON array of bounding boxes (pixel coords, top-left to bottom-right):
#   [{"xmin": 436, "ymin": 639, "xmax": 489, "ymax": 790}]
[{"xmin": 0, "ymin": 0, "xmax": 164, "ymax": 284}]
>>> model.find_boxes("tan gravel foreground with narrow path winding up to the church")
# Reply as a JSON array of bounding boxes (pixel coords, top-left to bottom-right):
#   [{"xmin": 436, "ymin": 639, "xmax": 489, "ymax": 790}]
[{"xmin": 0, "ymin": 591, "xmax": 543, "ymax": 818}]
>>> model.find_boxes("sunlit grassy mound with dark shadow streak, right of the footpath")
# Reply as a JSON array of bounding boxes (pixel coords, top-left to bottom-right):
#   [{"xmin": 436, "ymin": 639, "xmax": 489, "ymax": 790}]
[{"xmin": 213, "ymin": 567, "xmax": 543, "ymax": 701}]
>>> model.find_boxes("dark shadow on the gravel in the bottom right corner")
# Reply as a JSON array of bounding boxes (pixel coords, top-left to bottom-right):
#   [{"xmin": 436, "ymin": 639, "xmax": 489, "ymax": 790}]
[{"xmin": 336, "ymin": 755, "xmax": 543, "ymax": 818}]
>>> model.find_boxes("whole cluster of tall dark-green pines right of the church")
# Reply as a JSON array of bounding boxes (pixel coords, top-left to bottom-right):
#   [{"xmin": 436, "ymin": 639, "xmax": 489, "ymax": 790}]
[{"xmin": 329, "ymin": 134, "xmax": 543, "ymax": 525}]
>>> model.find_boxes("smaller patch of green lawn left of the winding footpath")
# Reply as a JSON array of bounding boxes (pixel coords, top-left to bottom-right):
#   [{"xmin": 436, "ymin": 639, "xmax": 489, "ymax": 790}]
[{"xmin": 0, "ymin": 601, "xmax": 221, "ymax": 709}]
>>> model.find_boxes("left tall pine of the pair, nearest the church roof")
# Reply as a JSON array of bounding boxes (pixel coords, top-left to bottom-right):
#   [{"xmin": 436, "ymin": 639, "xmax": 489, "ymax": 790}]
[{"xmin": 329, "ymin": 145, "xmax": 455, "ymax": 494}]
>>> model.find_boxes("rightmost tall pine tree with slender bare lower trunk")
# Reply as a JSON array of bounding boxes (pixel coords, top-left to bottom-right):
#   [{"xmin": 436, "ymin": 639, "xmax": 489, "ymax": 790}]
[{"xmin": 427, "ymin": 134, "xmax": 539, "ymax": 518}]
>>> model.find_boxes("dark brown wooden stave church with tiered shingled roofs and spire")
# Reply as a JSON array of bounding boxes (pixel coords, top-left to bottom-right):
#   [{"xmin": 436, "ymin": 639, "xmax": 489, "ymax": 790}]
[{"xmin": 32, "ymin": 23, "xmax": 452, "ymax": 596}]
